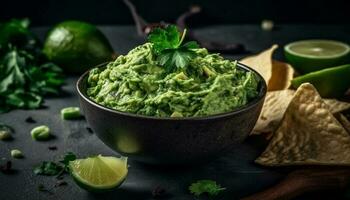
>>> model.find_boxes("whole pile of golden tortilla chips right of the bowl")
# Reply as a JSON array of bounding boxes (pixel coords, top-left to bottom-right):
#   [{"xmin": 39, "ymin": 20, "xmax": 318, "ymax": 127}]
[{"xmin": 241, "ymin": 45, "xmax": 350, "ymax": 166}]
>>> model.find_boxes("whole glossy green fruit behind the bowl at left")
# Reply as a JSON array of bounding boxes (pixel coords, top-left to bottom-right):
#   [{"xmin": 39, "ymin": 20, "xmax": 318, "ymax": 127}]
[{"xmin": 43, "ymin": 21, "xmax": 113, "ymax": 74}]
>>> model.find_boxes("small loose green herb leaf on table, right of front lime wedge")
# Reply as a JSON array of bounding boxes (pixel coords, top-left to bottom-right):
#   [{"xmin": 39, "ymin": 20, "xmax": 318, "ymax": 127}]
[{"xmin": 188, "ymin": 180, "xmax": 226, "ymax": 196}]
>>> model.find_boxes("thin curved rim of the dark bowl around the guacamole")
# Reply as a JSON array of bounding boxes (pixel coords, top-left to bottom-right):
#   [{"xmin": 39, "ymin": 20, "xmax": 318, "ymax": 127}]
[{"xmin": 76, "ymin": 62, "xmax": 267, "ymax": 121}]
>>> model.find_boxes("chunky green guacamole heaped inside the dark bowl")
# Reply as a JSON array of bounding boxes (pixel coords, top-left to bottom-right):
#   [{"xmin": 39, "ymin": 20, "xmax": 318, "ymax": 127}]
[{"xmin": 87, "ymin": 43, "xmax": 258, "ymax": 117}]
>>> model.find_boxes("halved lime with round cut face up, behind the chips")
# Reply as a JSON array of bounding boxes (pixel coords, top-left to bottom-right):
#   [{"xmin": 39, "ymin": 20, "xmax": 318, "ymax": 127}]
[{"xmin": 284, "ymin": 40, "xmax": 350, "ymax": 74}]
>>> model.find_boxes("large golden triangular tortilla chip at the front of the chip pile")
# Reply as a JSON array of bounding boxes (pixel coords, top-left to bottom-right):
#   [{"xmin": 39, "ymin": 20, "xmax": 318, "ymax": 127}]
[{"xmin": 256, "ymin": 83, "xmax": 350, "ymax": 166}]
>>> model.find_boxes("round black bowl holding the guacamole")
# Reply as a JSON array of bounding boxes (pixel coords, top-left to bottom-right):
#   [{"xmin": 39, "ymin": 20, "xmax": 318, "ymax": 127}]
[{"xmin": 77, "ymin": 64, "xmax": 267, "ymax": 164}]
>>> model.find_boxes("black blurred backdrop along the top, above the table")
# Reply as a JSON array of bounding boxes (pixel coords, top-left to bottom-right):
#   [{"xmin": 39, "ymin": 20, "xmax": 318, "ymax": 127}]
[{"xmin": 0, "ymin": 0, "xmax": 350, "ymax": 26}]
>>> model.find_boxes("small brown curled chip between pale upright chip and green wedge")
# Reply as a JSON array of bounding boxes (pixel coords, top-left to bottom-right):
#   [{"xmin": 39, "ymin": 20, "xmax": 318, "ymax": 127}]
[{"xmin": 267, "ymin": 60, "xmax": 294, "ymax": 91}]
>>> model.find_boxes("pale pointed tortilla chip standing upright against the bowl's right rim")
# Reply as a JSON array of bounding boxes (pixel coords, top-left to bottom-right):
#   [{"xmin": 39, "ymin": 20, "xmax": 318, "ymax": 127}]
[{"xmin": 240, "ymin": 44, "xmax": 278, "ymax": 83}]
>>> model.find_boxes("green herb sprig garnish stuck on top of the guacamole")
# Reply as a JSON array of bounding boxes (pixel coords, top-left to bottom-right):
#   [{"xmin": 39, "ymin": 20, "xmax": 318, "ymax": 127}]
[{"xmin": 148, "ymin": 25, "xmax": 199, "ymax": 72}]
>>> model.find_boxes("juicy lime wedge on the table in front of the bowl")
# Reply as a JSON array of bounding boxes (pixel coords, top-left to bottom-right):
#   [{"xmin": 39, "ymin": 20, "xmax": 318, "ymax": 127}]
[{"xmin": 69, "ymin": 155, "xmax": 128, "ymax": 192}]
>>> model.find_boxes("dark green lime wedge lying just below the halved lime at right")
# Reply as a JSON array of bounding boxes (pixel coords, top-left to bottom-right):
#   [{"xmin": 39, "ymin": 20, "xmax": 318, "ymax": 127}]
[{"xmin": 292, "ymin": 64, "xmax": 350, "ymax": 97}]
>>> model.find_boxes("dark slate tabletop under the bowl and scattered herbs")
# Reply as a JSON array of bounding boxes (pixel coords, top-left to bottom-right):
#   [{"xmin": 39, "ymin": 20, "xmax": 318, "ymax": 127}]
[{"xmin": 0, "ymin": 25, "xmax": 350, "ymax": 200}]
